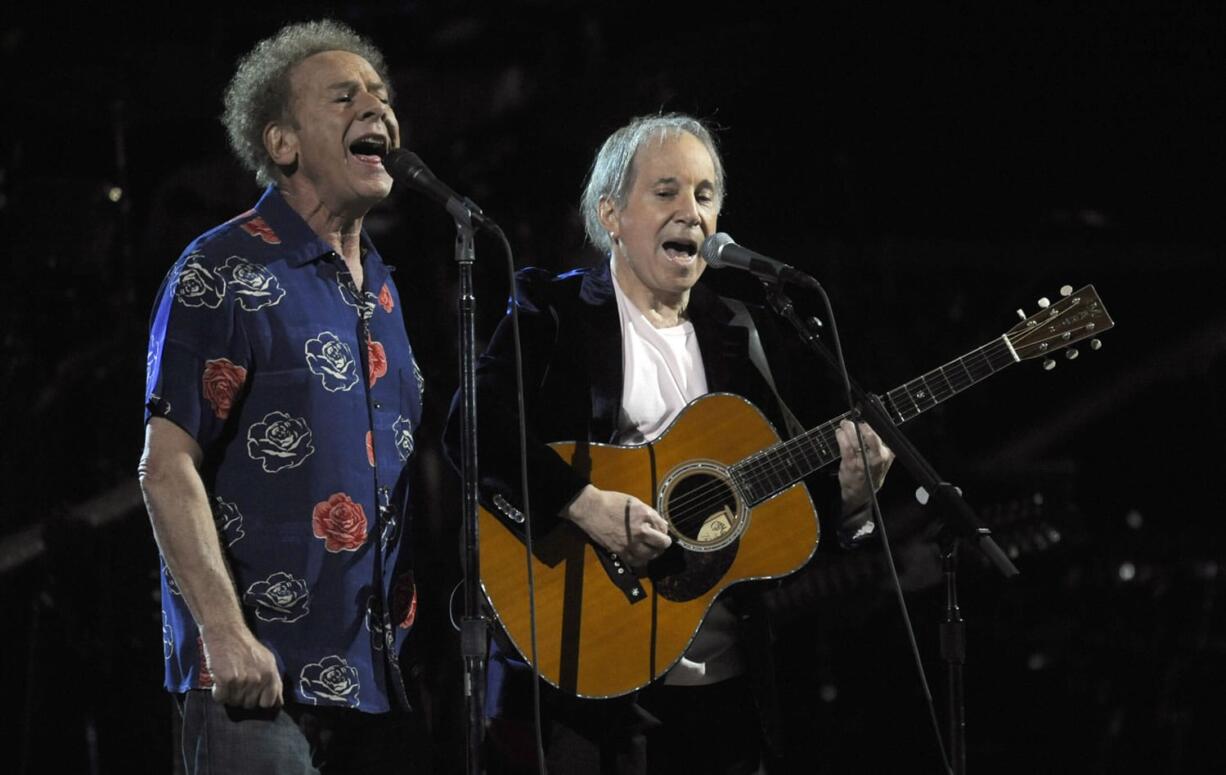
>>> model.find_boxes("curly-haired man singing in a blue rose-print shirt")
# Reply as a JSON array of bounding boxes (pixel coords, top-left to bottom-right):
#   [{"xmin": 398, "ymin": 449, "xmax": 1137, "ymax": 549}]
[{"xmin": 140, "ymin": 21, "xmax": 428, "ymax": 773}]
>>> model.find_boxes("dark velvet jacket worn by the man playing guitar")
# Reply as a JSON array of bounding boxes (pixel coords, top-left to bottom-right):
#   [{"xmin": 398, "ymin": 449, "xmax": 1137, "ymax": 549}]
[{"xmin": 444, "ymin": 264, "xmax": 837, "ymax": 750}]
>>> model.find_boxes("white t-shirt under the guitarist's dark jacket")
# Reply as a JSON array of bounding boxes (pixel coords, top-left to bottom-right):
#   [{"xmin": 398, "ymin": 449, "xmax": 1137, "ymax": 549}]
[{"xmin": 613, "ymin": 273, "xmax": 744, "ymax": 685}]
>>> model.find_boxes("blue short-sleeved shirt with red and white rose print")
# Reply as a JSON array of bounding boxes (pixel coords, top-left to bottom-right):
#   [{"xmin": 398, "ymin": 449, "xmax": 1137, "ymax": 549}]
[{"xmin": 145, "ymin": 186, "xmax": 422, "ymax": 712}]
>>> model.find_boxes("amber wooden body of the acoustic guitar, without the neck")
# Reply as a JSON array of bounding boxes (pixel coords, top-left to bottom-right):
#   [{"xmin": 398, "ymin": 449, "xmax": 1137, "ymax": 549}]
[{"xmin": 478, "ymin": 394, "xmax": 819, "ymax": 698}]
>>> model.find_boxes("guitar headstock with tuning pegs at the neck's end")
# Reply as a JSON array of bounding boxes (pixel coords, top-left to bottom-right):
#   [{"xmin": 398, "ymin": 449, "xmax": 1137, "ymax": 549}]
[{"xmin": 1005, "ymin": 286, "xmax": 1116, "ymax": 369}]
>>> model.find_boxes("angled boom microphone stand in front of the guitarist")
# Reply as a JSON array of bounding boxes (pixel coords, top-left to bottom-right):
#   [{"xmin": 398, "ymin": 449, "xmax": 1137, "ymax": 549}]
[{"xmin": 764, "ymin": 283, "xmax": 1019, "ymax": 775}]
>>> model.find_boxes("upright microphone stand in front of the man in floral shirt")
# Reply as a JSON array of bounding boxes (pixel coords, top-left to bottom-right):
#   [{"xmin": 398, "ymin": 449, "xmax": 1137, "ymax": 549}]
[{"xmin": 446, "ymin": 199, "xmax": 489, "ymax": 775}]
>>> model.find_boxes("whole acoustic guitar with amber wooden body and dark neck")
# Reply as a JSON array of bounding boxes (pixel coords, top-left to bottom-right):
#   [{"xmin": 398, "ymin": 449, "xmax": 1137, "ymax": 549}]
[{"xmin": 478, "ymin": 286, "xmax": 1114, "ymax": 698}]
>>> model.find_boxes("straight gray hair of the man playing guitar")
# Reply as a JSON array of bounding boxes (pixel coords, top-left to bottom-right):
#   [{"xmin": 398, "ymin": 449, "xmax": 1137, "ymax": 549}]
[{"xmin": 580, "ymin": 113, "xmax": 725, "ymax": 253}]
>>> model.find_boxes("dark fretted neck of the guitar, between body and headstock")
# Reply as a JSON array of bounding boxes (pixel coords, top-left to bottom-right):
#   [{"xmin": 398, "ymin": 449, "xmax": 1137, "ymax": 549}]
[{"xmin": 732, "ymin": 336, "xmax": 1021, "ymax": 506}]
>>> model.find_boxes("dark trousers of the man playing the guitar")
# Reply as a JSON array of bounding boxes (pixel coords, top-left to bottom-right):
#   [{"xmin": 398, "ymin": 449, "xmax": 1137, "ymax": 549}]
[{"xmin": 487, "ymin": 677, "xmax": 764, "ymax": 775}]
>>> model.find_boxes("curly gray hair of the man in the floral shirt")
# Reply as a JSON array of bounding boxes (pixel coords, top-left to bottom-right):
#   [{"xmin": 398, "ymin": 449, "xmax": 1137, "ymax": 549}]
[{"xmin": 222, "ymin": 20, "xmax": 391, "ymax": 185}]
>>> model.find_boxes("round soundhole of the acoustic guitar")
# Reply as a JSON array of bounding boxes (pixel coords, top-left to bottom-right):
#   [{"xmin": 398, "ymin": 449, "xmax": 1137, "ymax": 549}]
[{"xmin": 660, "ymin": 464, "xmax": 745, "ymax": 552}]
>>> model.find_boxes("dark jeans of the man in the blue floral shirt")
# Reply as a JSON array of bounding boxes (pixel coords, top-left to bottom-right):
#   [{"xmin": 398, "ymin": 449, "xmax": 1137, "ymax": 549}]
[{"xmin": 181, "ymin": 692, "xmax": 430, "ymax": 775}]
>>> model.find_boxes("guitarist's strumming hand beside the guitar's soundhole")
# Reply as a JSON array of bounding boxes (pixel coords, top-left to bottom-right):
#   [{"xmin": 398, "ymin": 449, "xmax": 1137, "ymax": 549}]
[{"xmin": 562, "ymin": 484, "xmax": 673, "ymax": 568}]
